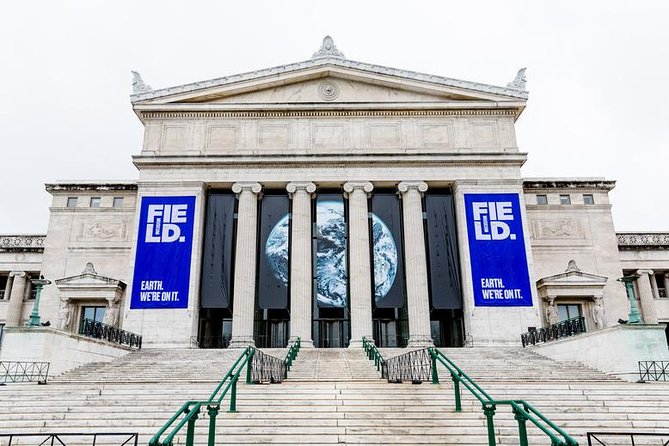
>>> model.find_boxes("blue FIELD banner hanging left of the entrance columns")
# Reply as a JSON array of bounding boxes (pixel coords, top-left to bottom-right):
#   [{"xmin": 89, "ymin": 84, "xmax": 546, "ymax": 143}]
[{"xmin": 130, "ymin": 197, "xmax": 195, "ymax": 309}]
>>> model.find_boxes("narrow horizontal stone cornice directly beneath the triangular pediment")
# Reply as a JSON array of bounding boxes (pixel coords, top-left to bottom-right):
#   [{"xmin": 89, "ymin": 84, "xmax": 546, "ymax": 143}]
[{"xmin": 139, "ymin": 108, "xmax": 517, "ymax": 119}]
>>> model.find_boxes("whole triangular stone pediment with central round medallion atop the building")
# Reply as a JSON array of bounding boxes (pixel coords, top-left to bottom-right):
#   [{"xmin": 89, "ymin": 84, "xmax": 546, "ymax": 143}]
[{"xmin": 131, "ymin": 47, "xmax": 527, "ymax": 114}]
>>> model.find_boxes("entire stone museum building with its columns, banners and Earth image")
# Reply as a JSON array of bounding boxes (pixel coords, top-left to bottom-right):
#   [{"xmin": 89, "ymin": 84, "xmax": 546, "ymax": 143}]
[{"xmin": 0, "ymin": 37, "xmax": 669, "ymax": 348}]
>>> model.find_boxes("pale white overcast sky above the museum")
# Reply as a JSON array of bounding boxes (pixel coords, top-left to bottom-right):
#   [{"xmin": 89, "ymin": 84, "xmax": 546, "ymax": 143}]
[{"xmin": 0, "ymin": 0, "xmax": 669, "ymax": 234}]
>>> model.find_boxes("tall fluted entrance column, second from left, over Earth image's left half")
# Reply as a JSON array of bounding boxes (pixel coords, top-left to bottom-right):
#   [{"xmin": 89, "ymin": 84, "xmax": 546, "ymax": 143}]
[{"xmin": 286, "ymin": 183, "xmax": 316, "ymax": 347}]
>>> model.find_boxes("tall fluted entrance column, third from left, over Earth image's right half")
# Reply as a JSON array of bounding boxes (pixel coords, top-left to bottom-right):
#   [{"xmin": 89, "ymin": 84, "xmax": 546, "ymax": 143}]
[{"xmin": 344, "ymin": 181, "xmax": 374, "ymax": 347}]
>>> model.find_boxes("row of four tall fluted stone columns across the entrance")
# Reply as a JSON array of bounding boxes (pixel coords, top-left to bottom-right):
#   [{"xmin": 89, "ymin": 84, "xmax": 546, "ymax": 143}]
[{"xmin": 230, "ymin": 181, "xmax": 432, "ymax": 347}]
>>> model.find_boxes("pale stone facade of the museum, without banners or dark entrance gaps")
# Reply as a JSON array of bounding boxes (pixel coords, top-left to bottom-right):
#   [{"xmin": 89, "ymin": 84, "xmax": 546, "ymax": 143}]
[{"xmin": 0, "ymin": 38, "xmax": 669, "ymax": 346}]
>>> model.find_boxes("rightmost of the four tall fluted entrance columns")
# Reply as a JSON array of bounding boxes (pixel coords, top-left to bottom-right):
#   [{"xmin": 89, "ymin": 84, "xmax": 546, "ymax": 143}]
[{"xmin": 397, "ymin": 181, "xmax": 434, "ymax": 348}]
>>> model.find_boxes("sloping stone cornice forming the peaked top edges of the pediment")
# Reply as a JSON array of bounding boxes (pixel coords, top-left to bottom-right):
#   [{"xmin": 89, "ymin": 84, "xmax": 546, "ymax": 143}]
[{"xmin": 130, "ymin": 57, "xmax": 528, "ymax": 104}]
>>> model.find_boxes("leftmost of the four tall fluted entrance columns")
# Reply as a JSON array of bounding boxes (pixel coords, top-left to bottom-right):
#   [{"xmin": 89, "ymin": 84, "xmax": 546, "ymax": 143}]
[{"xmin": 230, "ymin": 183, "xmax": 262, "ymax": 348}]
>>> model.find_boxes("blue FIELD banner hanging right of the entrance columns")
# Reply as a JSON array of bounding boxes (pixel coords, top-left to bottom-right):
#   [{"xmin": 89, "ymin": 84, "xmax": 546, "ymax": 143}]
[{"xmin": 465, "ymin": 194, "xmax": 532, "ymax": 307}]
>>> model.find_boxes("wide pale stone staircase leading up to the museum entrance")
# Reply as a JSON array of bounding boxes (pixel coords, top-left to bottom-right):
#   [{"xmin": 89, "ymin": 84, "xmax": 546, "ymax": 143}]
[{"xmin": 0, "ymin": 348, "xmax": 669, "ymax": 445}]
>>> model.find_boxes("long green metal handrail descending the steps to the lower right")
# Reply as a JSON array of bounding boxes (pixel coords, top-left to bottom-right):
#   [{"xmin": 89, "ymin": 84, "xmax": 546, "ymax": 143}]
[{"xmin": 428, "ymin": 348, "xmax": 578, "ymax": 446}]
